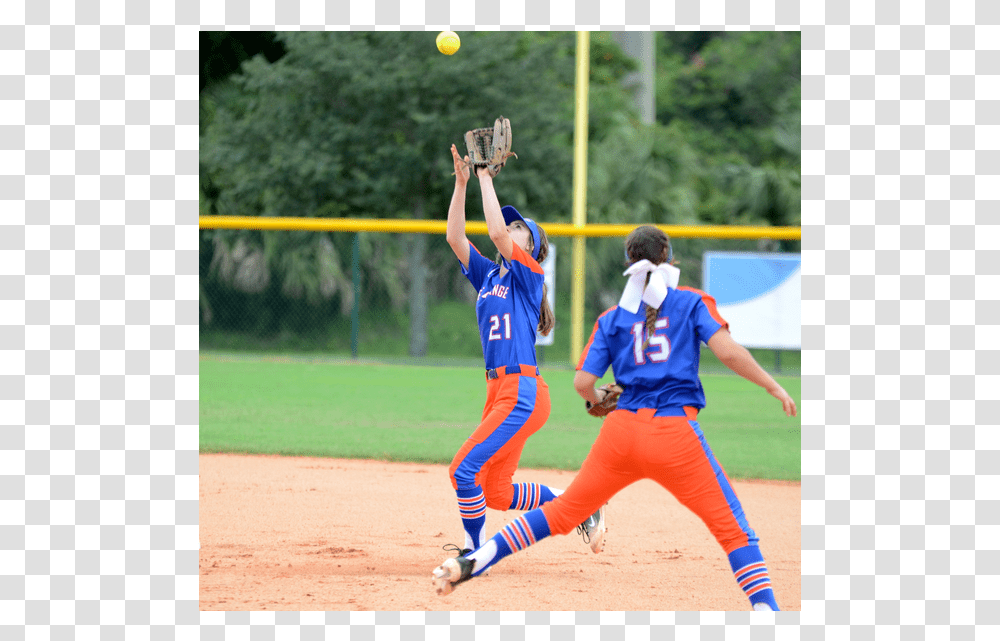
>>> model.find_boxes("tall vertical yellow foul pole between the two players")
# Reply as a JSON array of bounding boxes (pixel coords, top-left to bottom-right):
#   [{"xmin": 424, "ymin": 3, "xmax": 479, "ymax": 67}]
[{"xmin": 570, "ymin": 31, "xmax": 590, "ymax": 365}]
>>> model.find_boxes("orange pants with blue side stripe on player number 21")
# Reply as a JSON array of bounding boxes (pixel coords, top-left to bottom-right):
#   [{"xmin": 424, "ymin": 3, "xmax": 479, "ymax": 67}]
[{"xmin": 448, "ymin": 365, "xmax": 552, "ymax": 510}]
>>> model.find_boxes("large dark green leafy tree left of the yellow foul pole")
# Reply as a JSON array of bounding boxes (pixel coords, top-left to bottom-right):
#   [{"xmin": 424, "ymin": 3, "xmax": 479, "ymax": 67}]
[{"xmin": 202, "ymin": 32, "xmax": 573, "ymax": 351}]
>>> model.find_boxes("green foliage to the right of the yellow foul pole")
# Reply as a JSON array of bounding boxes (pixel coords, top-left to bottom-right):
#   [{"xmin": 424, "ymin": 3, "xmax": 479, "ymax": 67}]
[{"xmin": 580, "ymin": 32, "xmax": 801, "ymax": 314}]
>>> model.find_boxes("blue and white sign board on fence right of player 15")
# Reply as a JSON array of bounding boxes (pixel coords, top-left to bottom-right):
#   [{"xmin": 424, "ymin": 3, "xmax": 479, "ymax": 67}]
[{"xmin": 702, "ymin": 252, "xmax": 802, "ymax": 349}]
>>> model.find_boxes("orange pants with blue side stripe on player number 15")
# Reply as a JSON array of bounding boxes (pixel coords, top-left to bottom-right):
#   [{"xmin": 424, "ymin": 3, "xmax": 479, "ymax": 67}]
[{"xmin": 541, "ymin": 407, "xmax": 757, "ymax": 554}]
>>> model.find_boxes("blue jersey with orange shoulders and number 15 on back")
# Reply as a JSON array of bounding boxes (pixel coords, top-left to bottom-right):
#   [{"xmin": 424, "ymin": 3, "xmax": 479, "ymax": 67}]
[{"xmin": 577, "ymin": 287, "xmax": 729, "ymax": 416}]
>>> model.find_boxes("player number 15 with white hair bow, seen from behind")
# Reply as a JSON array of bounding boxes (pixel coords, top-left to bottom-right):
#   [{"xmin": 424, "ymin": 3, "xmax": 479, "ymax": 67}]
[{"xmin": 433, "ymin": 226, "xmax": 796, "ymax": 610}]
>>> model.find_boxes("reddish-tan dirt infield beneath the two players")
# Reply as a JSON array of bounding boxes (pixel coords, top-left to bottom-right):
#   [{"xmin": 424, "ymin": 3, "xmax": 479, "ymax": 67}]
[{"xmin": 198, "ymin": 454, "xmax": 801, "ymax": 611}]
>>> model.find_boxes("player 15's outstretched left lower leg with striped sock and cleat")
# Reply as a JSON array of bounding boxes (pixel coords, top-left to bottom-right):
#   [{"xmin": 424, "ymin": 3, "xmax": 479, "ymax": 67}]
[{"xmin": 432, "ymin": 509, "xmax": 550, "ymax": 596}]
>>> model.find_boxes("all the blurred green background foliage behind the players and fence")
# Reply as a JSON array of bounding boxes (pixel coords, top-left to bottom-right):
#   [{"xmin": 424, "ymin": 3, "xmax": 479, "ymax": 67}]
[{"xmin": 200, "ymin": 32, "xmax": 801, "ymax": 360}]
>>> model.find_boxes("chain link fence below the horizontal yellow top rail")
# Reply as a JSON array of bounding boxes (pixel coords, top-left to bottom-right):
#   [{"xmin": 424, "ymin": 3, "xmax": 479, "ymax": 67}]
[{"xmin": 200, "ymin": 229, "xmax": 800, "ymax": 374}]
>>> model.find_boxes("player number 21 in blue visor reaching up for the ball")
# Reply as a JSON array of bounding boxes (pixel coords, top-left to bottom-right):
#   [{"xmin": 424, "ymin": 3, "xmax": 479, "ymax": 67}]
[{"xmin": 446, "ymin": 145, "xmax": 604, "ymax": 556}]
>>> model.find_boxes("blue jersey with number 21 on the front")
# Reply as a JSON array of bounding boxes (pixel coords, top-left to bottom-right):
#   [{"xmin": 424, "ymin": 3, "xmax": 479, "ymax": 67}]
[{"xmin": 462, "ymin": 242, "xmax": 545, "ymax": 369}]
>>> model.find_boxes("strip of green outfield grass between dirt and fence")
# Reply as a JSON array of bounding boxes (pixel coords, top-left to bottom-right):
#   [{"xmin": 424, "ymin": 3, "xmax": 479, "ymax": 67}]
[{"xmin": 199, "ymin": 353, "xmax": 801, "ymax": 480}]
